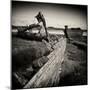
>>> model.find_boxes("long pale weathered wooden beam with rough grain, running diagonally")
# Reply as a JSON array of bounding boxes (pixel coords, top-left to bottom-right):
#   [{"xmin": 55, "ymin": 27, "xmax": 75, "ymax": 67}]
[{"xmin": 24, "ymin": 38, "xmax": 66, "ymax": 88}]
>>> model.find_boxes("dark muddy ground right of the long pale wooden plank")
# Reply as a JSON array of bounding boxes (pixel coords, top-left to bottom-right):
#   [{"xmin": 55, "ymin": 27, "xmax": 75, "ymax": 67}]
[{"xmin": 59, "ymin": 37, "xmax": 87, "ymax": 86}]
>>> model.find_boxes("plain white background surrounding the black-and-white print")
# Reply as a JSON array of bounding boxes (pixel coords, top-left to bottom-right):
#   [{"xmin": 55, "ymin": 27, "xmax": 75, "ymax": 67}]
[{"xmin": 0, "ymin": 0, "xmax": 90, "ymax": 90}]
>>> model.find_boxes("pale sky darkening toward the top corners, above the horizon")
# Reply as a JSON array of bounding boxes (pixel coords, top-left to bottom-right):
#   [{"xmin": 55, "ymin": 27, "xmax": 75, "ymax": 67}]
[{"xmin": 11, "ymin": 1, "xmax": 87, "ymax": 29}]
